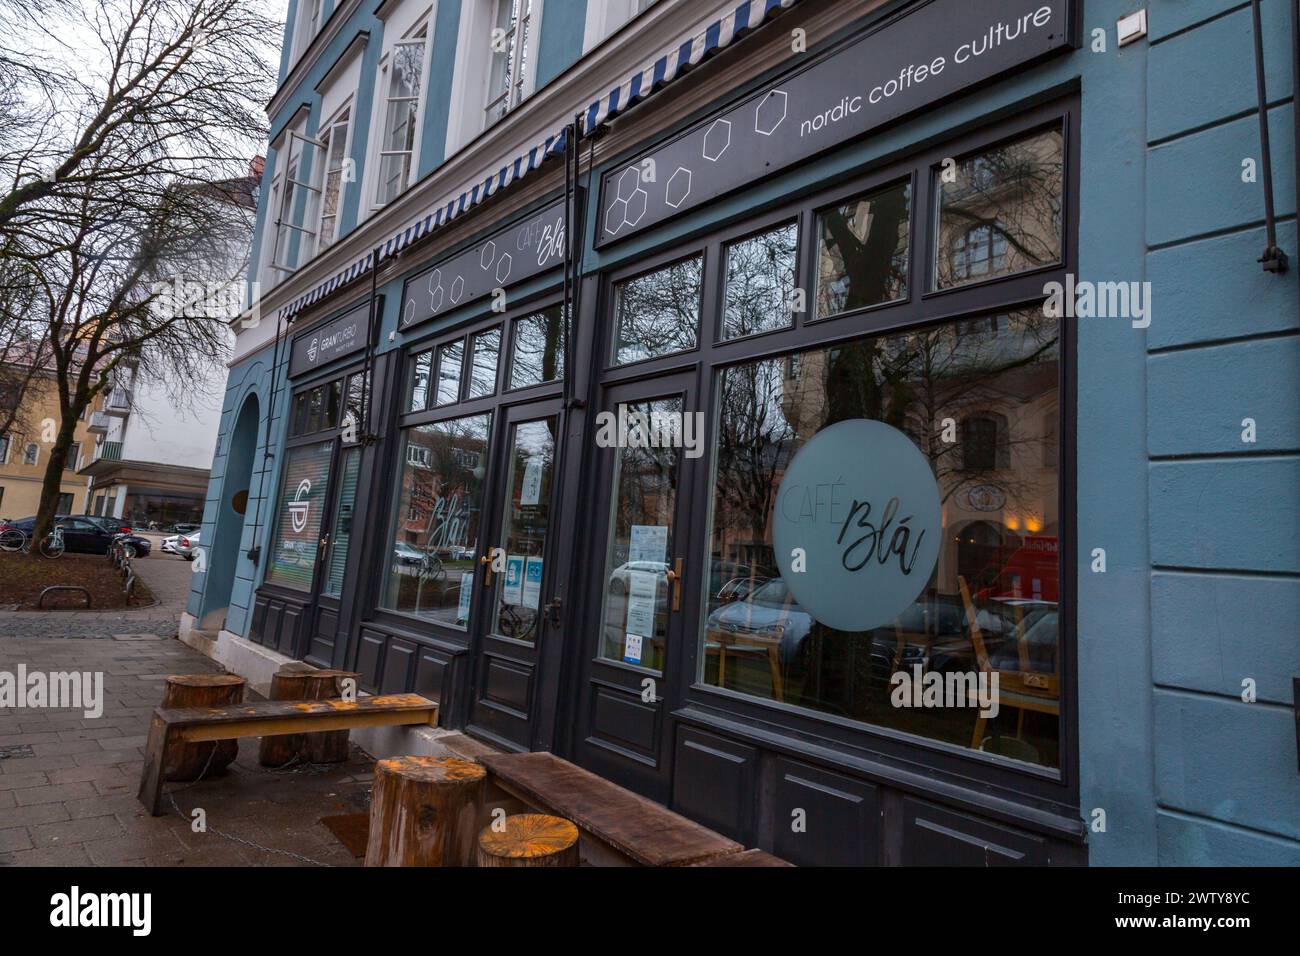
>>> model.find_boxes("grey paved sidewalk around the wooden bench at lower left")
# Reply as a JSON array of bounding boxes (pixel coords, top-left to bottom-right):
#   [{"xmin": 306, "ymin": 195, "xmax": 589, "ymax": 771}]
[{"xmin": 0, "ymin": 629, "xmax": 372, "ymax": 866}]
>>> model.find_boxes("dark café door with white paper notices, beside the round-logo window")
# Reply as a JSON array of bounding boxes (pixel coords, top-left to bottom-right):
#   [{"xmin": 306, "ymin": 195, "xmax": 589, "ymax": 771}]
[{"xmin": 572, "ymin": 373, "xmax": 698, "ymax": 801}]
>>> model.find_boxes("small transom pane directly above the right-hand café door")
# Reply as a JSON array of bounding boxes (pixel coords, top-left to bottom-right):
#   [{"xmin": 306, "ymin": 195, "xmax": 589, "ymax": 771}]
[{"xmin": 614, "ymin": 258, "xmax": 703, "ymax": 365}]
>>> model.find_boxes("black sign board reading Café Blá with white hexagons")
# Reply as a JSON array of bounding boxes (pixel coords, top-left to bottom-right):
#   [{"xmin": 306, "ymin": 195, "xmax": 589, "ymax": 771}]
[{"xmin": 399, "ymin": 199, "xmax": 566, "ymax": 329}]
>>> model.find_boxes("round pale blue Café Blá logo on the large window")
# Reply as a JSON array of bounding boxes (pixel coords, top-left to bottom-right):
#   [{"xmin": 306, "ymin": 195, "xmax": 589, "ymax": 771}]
[{"xmin": 772, "ymin": 419, "xmax": 943, "ymax": 631}]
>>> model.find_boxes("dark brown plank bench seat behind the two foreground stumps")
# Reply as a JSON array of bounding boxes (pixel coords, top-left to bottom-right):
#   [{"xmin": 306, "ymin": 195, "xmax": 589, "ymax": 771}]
[{"xmin": 478, "ymin": 753, "xmax": 745, "ymax": 866}]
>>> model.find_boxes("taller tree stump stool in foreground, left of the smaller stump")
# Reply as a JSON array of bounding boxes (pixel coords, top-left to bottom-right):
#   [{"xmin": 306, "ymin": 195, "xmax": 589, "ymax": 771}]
[{"xmin": 365, "ymin": 757, "xmax": 488, "ymax": 866}]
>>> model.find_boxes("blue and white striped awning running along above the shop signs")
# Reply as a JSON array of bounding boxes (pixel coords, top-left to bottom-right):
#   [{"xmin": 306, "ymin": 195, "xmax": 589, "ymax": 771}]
[{"xmin": 280, "ymin": 0, "xmax": 800, "ymax": 319}]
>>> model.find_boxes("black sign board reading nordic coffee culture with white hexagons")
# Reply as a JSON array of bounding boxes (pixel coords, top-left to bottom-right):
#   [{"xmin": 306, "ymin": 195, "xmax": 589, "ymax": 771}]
[{"xmin": 597, "ymin": 0, "xmax": 1074, "ymax": 246}]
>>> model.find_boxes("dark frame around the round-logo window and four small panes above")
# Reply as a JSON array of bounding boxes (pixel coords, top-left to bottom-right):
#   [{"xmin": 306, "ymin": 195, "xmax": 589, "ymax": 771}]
[{"xmin": 585, "ymin": 92, "xmax": 1079, "ymax": 819}]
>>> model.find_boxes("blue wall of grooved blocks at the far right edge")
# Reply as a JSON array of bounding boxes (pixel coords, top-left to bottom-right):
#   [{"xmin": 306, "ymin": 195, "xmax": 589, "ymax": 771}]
[{"xmin": 1144, "ymin": 0, "xmax": 1300, "ymax": 865}]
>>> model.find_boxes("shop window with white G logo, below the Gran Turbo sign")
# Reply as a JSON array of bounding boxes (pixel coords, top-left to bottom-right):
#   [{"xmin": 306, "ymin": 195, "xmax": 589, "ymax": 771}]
[{"xmin": 267, "ymin": 441, "xmax": 334, "ymax": 591}]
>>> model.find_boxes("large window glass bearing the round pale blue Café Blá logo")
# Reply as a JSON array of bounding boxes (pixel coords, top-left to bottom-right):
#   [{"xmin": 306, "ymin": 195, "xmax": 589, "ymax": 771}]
[{"xmin": 707, "ymin": 314, "xmax": 1061, "ymax": 767}]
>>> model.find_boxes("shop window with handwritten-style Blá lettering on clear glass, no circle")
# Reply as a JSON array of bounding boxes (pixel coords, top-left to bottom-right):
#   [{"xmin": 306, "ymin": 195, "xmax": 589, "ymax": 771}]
[{"xmin": 384, "ymin": 415, "xmax": 491, "ymax": 630}]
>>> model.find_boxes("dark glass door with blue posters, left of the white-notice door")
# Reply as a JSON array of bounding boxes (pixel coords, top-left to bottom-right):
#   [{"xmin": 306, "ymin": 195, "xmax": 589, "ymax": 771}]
[{"xmin": 469, "ymin": 401, "xmax": 562, "ymax": 749}]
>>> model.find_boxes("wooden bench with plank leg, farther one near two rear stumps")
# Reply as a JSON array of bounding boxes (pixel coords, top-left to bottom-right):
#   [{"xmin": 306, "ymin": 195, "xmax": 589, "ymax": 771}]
[{"xmin": 138, "ymin": 693, "xmax": 438, "ymax": 817}]
